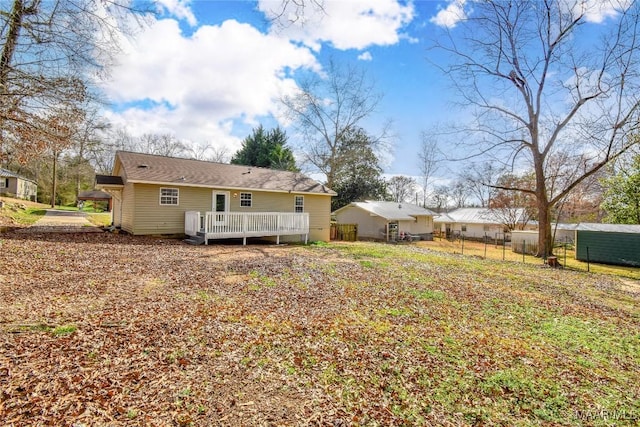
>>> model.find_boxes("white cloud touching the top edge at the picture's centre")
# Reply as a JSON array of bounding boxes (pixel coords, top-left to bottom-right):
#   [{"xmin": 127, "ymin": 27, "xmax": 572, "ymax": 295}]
[{"xmin": 258, "ymin": 0, "xmax": 415, "ymax": 51}]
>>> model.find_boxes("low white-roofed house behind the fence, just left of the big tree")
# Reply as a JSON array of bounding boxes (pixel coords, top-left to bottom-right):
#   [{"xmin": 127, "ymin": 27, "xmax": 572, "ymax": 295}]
[{"xmin": 434, "ymin": 208, "xmax": 534, "ymax": 239}]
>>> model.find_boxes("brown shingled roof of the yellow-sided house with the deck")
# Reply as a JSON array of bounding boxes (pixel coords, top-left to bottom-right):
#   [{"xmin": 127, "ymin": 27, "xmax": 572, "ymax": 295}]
[{"xmin": 116, "ymin": 151, "xmax": 336, "ymax": 196}]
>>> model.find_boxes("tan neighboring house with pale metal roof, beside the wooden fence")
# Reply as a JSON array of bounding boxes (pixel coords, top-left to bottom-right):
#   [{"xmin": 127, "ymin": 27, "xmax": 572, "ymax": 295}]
[{"xmin": 333, "ymin": 201, "xmax": 435, "ymax": 241}]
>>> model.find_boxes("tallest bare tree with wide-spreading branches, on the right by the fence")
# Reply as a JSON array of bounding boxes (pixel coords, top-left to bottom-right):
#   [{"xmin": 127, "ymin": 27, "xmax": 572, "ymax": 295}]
[{"xmin": 438, "ymin": 0, "xmax": 640, "ymax": 256}]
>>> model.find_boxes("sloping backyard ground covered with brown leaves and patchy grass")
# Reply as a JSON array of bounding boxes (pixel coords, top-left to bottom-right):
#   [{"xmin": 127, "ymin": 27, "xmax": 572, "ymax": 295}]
[{"xmin": 0, "ymin": 233, "xmax": 640, "ymax": 426}]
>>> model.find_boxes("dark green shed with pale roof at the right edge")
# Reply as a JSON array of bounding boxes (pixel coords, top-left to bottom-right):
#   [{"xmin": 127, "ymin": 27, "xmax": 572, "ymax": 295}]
[{"xmin": 576, "ymin": 223, "xmax": 640, "ymax": 267}]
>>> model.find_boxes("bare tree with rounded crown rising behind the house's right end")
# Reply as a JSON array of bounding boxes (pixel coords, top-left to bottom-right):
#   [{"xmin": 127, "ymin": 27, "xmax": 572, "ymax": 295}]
[{"xmin": 282, "ymin": 61, "xmax": 389, "ymax": 188}]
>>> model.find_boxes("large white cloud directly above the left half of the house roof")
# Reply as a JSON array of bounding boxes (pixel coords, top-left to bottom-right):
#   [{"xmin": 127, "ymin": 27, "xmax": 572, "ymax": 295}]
[{"xmin": 104, "ymin": 19, "xmax": 320, "ymax": 153}]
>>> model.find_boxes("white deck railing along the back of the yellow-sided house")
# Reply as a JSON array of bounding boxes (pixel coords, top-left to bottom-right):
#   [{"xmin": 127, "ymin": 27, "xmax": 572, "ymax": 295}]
[{"xmin": 184, "ymin": 211, "xmax": 309, "ymax": 244}]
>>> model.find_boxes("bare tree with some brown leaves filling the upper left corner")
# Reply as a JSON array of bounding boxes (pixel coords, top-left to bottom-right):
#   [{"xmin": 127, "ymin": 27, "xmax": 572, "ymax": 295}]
[{"xmin": 0, "ymin": 0, "xmax": 146, "ymax": 161}]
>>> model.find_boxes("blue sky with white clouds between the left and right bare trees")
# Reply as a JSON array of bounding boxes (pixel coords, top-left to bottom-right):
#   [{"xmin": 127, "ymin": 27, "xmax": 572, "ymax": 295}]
[{"xmin": 104, "ymin": 0, "xmax": 628, "ymax": 182}]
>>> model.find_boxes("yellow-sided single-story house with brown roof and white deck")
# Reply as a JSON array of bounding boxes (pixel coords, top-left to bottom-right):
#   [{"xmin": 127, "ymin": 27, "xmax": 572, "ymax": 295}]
[{"xmin": 96, "ymin": 151, "xmax": 336, "ymax": 243}]
